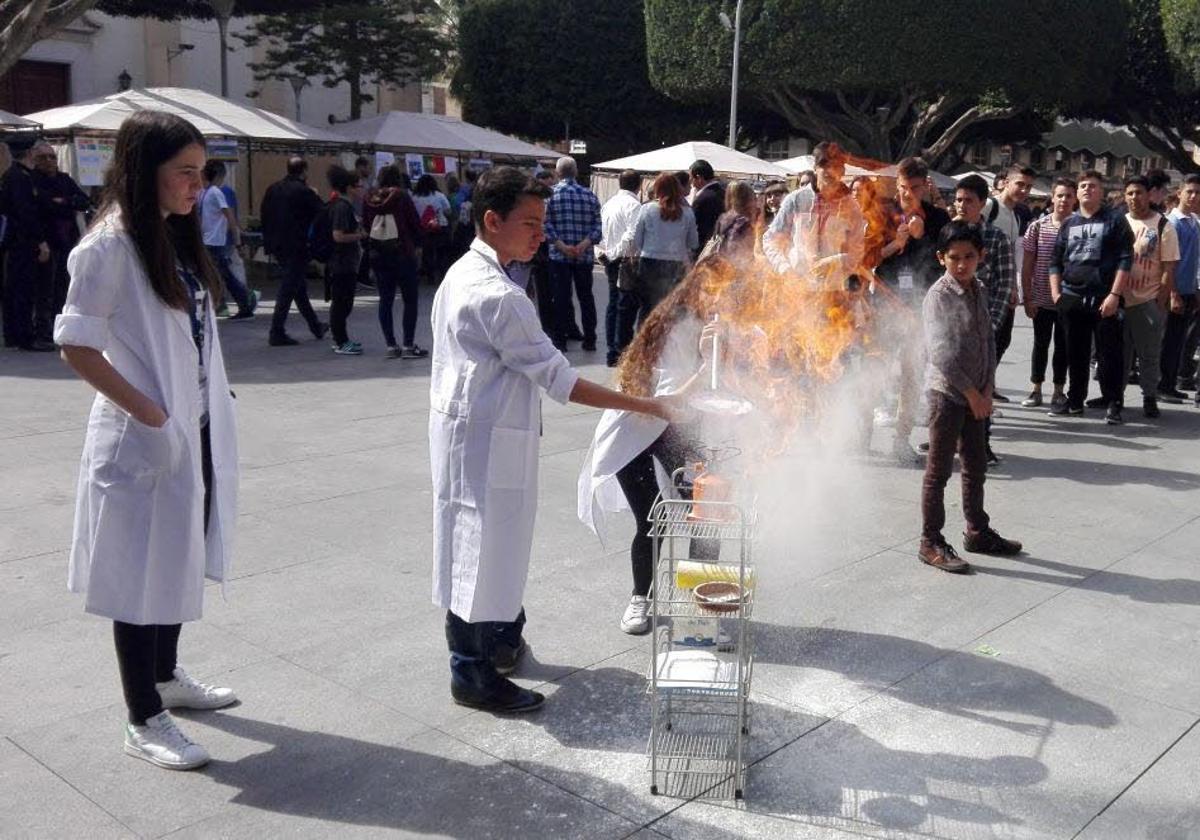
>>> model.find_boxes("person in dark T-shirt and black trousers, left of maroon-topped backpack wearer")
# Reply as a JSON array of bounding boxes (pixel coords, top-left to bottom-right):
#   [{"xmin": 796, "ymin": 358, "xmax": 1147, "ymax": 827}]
[{"xmin": 318, "ymin": 166, "xmax": 367, "ymax": 356}]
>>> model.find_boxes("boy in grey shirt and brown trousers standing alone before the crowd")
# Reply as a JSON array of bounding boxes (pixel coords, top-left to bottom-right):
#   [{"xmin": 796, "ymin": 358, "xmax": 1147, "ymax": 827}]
[{"xmin": 918, "ymin": 221, "xmax": 1021, "ymax": 572}]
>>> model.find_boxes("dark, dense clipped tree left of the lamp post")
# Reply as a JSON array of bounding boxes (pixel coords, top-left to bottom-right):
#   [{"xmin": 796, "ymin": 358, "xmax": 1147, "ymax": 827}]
[{"xmin": 451, "ymin": 0, "xmax": 748, "ymax": 160}]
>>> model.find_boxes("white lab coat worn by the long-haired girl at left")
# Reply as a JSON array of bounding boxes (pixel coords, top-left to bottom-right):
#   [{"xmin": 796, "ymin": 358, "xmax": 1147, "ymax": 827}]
[{"xmin": 54, "ymin": 214, "xmax": 238, "ymax": 624}]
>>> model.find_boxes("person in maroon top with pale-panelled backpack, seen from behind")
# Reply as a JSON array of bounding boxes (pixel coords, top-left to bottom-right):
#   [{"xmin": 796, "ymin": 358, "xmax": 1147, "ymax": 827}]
[{"xmin": 362, "ymin": 166, "xmax": 430, "ymax": 359}]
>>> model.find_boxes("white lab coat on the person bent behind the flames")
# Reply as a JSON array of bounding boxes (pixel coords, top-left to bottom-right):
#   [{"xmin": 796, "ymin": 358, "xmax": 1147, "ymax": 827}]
[{"xmin": 576, "ymin": 317, "xmax": 703, "ymax": 542}]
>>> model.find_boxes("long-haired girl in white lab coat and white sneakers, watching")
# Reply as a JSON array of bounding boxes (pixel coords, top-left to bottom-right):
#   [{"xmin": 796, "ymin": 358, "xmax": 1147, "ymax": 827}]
[{"xmin": 54, "ymin": 110, "xmax": 238, "ymax": 769}]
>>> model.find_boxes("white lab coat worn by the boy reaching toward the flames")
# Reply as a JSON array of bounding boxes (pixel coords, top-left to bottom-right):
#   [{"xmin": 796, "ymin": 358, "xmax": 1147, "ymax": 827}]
[{"xmin": 430, "ymin": 239, "xmax": 578, "ymax": 622}]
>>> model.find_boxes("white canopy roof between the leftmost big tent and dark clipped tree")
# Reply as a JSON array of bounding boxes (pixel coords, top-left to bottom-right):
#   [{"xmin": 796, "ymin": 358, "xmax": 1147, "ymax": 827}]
[{"xmin": 337, "ymin": 110, "xmax": 559, "ymax": 161}]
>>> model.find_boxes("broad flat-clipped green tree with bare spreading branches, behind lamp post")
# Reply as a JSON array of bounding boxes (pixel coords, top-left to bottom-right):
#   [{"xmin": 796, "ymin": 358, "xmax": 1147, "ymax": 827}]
[{"xmin": 646, "ymin": 0, "xmax": 1123, "ymax": 162}]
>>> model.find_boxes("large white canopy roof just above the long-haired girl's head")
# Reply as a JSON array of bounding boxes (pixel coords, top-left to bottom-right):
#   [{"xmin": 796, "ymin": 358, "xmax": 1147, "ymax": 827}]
[{"xmin": 28, "ymin": 88, "xmax": 346, "ymax": 145}]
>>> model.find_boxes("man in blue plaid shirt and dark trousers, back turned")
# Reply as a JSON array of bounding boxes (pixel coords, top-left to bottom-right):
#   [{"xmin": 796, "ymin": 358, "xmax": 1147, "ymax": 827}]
[{"xmin": 546, "ymin": 157, "xmax": 601, "ymax": 352}]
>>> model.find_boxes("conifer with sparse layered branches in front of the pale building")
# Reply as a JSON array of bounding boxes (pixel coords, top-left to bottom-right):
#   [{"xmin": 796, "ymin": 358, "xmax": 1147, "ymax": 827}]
[{"xmin": 239, "ymin": 0, "xmax": 450, "ymax": 120}]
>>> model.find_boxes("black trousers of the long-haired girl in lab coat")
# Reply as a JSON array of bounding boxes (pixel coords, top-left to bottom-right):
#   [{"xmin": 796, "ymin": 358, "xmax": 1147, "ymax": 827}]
[{"xmin": 113, "ymin": 426, "xmax": 212, "ymax": 726}]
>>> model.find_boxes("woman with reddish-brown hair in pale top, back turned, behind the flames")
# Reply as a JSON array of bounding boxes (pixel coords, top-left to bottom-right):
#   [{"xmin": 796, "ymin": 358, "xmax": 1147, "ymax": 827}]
[{"xmin": 620, "ymin": 172, "xmax": 700, "ymax": 329}]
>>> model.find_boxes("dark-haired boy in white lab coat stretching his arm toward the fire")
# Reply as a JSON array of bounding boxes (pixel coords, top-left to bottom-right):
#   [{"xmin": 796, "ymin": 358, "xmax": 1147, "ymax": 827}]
[{"xmin": 430, "ymin": 167, "xmax": 672, "ymax": 712}]
